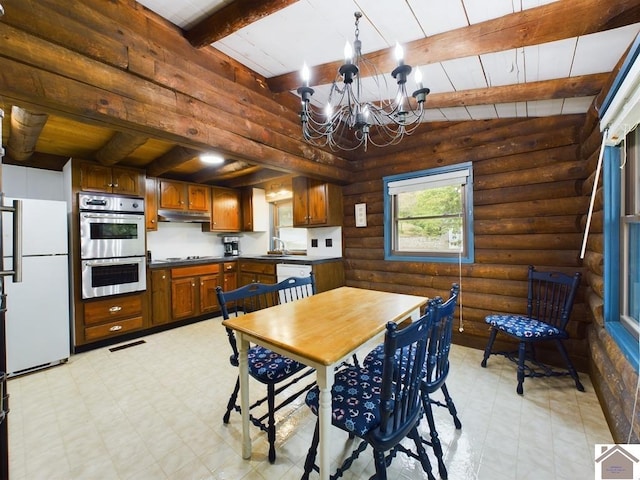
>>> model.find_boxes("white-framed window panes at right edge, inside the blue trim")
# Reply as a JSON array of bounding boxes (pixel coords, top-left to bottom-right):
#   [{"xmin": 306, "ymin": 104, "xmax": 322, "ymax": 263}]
[{"xmin": 620, "ymin": 128, "xmax": 640, "ymax": 340}]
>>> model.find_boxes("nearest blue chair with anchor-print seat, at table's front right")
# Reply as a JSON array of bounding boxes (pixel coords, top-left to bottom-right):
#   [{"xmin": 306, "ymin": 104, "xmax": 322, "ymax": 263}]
[{"xmin": 302, "ymin": 296, "xmax": 436, "ymax": 480}]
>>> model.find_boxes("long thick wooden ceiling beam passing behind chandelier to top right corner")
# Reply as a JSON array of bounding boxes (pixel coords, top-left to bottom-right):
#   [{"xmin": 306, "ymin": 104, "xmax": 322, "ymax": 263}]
[{"xmin": 267, "ymin": 0, "xmax": 640, "ymax": 92}]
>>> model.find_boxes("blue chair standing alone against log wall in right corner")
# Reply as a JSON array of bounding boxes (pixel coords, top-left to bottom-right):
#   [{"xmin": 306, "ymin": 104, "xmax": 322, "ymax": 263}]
[{"xmin": 481, "ymin": 266, "xmax": 584, "ymax": 395}]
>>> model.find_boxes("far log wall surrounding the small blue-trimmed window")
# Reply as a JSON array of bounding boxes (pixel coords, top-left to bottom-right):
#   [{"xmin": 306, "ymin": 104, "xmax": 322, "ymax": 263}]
[{"xmin": 343, "ymin": 115, "xmax": 597, "ymax": 372}]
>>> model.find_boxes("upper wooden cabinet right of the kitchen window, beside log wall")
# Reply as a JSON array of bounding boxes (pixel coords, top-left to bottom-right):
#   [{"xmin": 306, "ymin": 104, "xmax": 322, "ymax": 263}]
[{"xmin": 292, "ymin": 177, "xmax": 344, "ymax": 227}]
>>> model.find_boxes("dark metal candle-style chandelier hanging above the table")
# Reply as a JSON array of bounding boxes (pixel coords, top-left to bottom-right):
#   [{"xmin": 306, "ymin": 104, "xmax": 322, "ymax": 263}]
[{"xmin": 297, "ymin": 12, "xmax": 429, "ymax": 151}]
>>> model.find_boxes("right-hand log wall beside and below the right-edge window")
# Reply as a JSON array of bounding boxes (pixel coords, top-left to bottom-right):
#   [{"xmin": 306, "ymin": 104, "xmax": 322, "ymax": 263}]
[{"xmin": 580, "ymin": 107, "xmax": 640, "ymax": 443}]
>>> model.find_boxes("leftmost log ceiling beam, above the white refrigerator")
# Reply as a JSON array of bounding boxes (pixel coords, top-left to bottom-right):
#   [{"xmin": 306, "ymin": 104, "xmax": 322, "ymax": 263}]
[{"xmin": 7, "ymin": 105, "xmax": 49, "ymax": 162}]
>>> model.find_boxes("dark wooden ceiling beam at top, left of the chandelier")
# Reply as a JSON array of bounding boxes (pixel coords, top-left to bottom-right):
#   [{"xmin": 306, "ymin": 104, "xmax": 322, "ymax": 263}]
[{"xmin": 184, "ymin": 0, "xmax": 298, "ymax": 48}]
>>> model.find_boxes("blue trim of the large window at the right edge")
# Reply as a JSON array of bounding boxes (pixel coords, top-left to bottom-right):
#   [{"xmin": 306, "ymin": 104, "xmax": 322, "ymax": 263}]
[{"xmin": 603, "ymin": 146, "xmax": 640, "ymax": 372}]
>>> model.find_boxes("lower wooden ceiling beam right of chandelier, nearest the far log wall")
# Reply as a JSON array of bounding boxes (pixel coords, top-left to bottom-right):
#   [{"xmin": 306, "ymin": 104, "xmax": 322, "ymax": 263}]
[{"xmin": 425, "ymin": 73, "xmax": 609, "ymax": 108}]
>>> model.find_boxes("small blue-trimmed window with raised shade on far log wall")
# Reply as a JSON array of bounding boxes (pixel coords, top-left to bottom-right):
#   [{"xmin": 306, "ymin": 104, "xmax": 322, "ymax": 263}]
[{"xmin": 383, "ymin": 162, "xmax": 473, "ymax": 263}]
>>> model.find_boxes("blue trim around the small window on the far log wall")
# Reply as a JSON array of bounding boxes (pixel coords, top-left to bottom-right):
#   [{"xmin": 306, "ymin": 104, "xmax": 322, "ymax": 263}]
[{"xmin": 382, "ymin": 162, "xmax": 474, "ymax": 263}]
